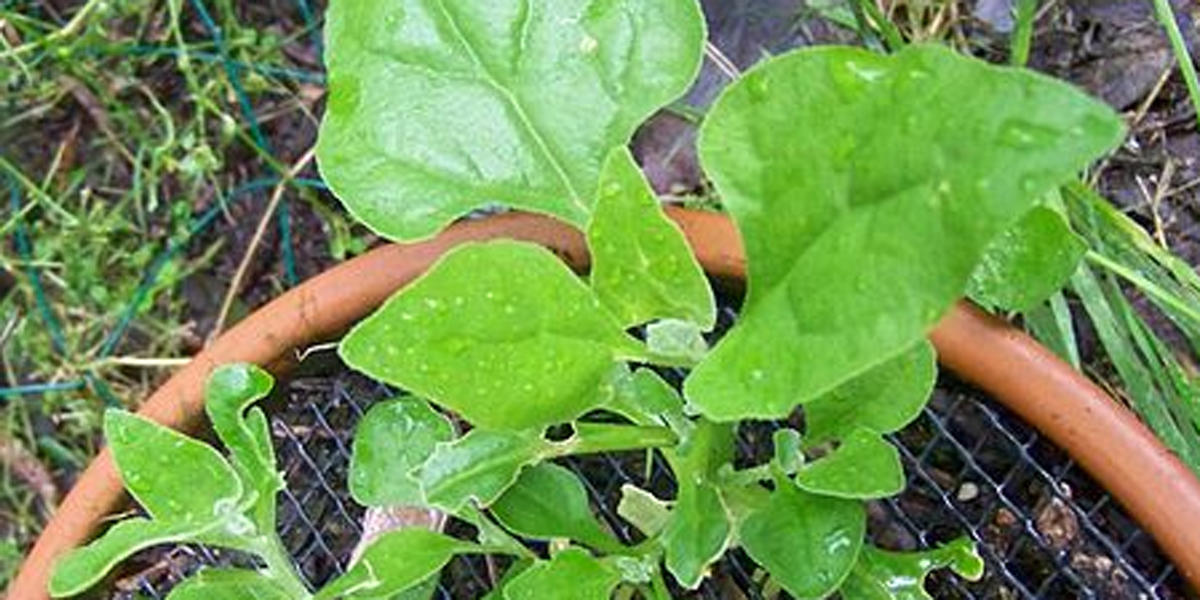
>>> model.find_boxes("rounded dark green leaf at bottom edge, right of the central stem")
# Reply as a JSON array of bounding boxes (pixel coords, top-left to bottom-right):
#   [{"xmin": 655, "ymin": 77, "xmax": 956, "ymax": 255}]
[{"xmin": 738, "ymin": 484, "xmax": 866, "ymax": 600}]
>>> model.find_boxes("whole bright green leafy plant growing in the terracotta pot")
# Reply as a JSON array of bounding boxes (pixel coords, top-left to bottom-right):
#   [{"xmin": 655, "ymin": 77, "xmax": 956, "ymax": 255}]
[{"xmin": 46, "ymin": 0, "xmax": 1122, "ymax": 600}]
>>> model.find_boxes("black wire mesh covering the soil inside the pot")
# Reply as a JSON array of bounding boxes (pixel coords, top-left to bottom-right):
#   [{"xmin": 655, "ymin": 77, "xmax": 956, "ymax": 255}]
[{"xmin": 100, "ymin": 311, "xmax": 1190, "ymax": 599}]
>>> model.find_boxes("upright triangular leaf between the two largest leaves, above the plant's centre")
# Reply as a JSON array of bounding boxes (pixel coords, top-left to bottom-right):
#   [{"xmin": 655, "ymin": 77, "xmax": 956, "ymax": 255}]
[{"xmin": 588, "ymin": 146, "xmax": 716, "ymax": 329}]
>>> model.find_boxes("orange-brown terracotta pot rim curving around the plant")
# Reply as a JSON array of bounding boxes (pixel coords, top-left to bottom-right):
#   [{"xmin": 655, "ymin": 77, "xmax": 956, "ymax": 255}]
[{"xmin": 8, "ymin": 209, "xmax": 1200, "ymax": 600}]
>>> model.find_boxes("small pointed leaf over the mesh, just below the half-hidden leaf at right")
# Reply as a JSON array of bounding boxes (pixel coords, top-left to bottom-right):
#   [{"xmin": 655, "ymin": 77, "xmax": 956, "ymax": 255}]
[{"xmin": 796, "ymin": 430, "xmax": 905, "ymax": 499}]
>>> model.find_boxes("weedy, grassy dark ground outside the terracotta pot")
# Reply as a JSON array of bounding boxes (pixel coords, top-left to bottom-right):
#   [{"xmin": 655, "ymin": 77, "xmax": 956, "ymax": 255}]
[{"xmin": 0, "ymin": 0, "xmax": 1200, "ymax": 592}]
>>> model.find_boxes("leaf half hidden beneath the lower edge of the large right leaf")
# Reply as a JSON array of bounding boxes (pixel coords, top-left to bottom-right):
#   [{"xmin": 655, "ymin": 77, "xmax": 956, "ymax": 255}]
[{"xmin": 804, "ymin": 341, "xmax": 937, "ymax": 444}]
